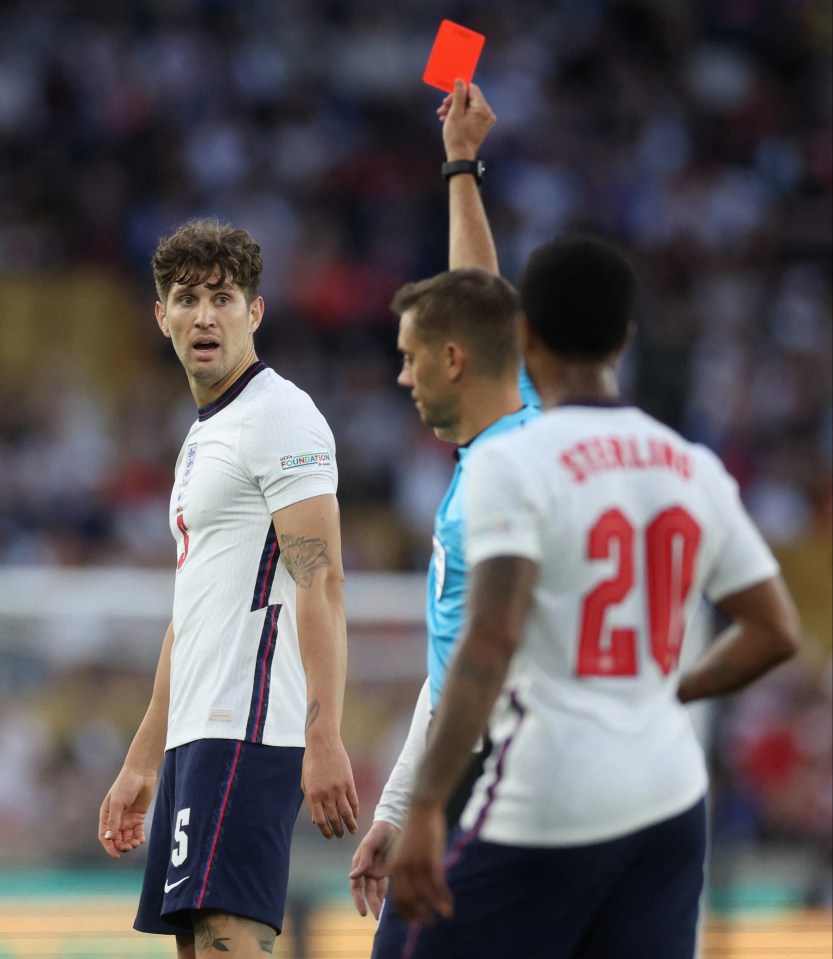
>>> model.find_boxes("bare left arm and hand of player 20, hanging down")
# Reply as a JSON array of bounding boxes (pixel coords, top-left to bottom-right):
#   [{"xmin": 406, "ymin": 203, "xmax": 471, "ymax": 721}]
[{"xmin": 391, "ymin": 556, "xmax": 536, "ymax": 923}]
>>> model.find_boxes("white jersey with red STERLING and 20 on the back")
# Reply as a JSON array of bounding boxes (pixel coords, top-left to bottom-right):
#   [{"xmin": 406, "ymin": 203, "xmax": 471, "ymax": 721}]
[{"xmin": 463, "ymin": 406, "xmax": 778, "ymax": 845}]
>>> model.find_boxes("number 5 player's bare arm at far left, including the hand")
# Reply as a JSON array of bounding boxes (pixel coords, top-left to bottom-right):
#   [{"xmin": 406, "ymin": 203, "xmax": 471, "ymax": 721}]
[{"xmin": 98, "ymin": 625, "xmax": 174, "ymax": 859}]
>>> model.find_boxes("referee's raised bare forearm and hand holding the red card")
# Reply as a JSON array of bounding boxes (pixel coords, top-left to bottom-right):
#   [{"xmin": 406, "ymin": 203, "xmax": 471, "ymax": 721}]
[{"xmin": 438, "ymin": 80, "xmax": 500, "ymax": 273}]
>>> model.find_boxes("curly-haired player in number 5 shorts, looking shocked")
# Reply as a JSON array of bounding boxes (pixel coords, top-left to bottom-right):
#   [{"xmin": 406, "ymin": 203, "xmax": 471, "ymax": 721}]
[{"xmin": 99, "ymin": 219, "xmax": 358, "ymax": 959}]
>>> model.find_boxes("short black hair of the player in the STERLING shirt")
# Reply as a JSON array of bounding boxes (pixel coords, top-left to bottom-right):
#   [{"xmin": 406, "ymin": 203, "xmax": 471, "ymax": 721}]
[{"xmin": 519, "ymin": 235, "xmax": 636, "ymax": 359}]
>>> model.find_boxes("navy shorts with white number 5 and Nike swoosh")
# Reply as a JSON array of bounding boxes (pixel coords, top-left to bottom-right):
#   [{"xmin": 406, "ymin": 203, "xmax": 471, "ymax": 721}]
[{"xmin": 133, "ymin": 739, "xmax": 304, "ymax": 935}]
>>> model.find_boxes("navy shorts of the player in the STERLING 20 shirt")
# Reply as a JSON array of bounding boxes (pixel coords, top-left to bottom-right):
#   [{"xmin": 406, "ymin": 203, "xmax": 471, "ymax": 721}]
[{"xmin": 403, "ymin": 800, "xmax": 706, "ymax": 959}]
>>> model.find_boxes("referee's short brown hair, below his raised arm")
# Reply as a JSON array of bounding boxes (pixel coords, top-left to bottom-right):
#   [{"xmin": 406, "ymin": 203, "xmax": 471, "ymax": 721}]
[{"xmin": 391, "ymin": 268, "xmax": 521, "ymax": 377}]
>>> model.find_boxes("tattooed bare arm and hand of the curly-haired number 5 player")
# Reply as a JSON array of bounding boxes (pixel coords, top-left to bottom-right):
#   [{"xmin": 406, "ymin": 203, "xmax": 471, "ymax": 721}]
[{"xmin": 272, "ymin": 495, "xmax": 359, "ymax": 839}]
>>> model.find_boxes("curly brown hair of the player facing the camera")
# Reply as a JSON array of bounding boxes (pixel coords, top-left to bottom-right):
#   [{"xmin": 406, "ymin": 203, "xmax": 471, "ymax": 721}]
[{"xmin": 151, "ymin": 217, "xmax": 263, "ymax": 303}]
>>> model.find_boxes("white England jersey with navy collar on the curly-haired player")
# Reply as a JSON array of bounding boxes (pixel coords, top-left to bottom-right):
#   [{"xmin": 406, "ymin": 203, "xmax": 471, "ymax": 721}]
[{"xmin": 166, "ymin": 362, "xmax": 337, "ymax": 749}]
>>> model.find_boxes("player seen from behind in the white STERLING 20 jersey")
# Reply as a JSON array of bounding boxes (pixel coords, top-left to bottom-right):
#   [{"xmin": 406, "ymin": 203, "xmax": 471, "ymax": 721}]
[{"xmin": 391, "ymin": 237, "xmax": 798, "ymax": 959}]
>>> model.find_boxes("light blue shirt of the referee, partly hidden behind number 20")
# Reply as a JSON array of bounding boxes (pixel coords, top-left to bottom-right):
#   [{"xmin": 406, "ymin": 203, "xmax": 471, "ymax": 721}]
[{"xmin": 425, "ymin": 392, "xmax": 541, "ymax": 709}]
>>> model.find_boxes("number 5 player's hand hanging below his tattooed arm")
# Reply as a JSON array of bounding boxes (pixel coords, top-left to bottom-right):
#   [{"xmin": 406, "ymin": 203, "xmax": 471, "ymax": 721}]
[{"xmin": 301, "ymin": 738, "xmax": 359, "ymax": 839}]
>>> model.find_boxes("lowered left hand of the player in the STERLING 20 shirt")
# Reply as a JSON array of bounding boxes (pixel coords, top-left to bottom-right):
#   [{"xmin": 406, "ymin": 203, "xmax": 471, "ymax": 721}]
[{"xmin": 390, "ymin": 805, "xmax": 454, "ymax": 925}]
